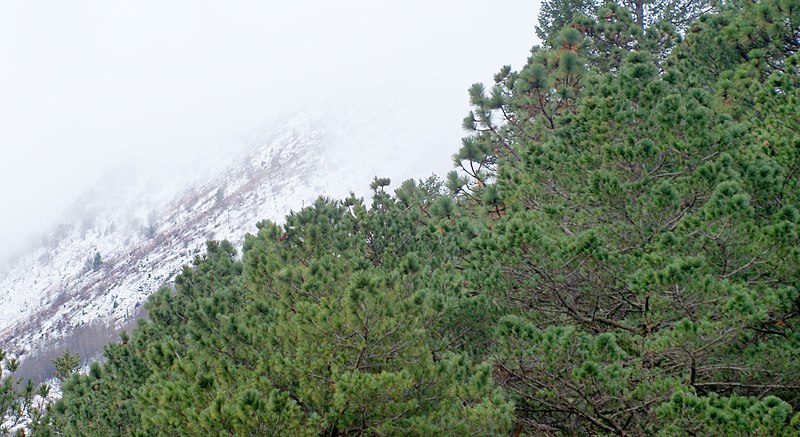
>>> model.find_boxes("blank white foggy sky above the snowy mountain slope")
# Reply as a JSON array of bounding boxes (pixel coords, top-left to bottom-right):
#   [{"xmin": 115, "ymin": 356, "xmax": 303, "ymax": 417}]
[{"xmin": 0, "ymin": 0, "xmax": 538, "ymax": 263}]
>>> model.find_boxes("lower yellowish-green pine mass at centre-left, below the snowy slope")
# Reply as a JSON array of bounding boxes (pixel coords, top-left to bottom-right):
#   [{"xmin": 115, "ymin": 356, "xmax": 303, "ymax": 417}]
[{"xmin": 43, "ymin": 192, "xmax": 511, "ymax": 435}]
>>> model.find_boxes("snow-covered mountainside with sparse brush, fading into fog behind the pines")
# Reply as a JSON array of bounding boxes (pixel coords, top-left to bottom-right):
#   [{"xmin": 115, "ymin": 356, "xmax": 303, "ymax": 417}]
[{"xmin": 0, "ymin": 114, "xmax": 438, "ymax": 359}]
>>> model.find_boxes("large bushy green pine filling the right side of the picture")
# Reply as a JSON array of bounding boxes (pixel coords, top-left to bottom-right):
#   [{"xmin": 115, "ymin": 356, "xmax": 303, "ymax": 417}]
[{"xmin": 460, "ymin": 0, "xmax": 800, "ymax": 435}]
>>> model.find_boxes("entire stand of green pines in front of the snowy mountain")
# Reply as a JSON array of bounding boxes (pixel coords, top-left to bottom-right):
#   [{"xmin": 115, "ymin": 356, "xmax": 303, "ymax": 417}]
[{"xmin": 0, "ymin": 0, "xmax": 800, "ymax": 436}]
